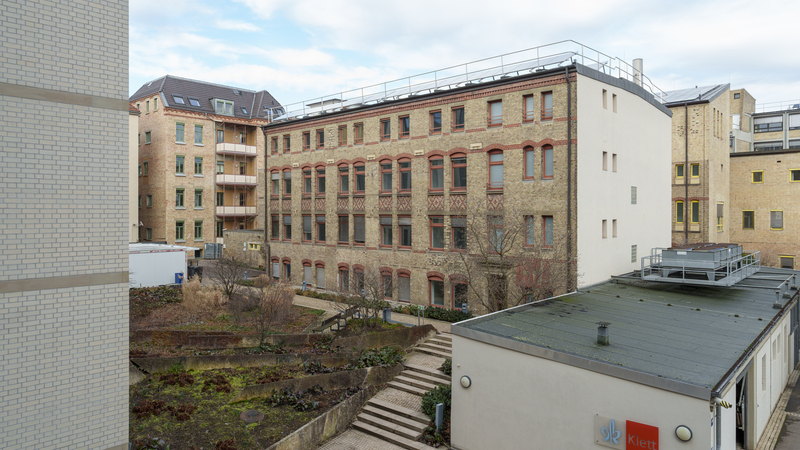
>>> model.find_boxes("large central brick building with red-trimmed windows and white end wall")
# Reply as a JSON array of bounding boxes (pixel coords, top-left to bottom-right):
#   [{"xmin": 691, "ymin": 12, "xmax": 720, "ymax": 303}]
[{"xmin": 263, "ymin": 47, "xmax": 670, "ymax": 308}]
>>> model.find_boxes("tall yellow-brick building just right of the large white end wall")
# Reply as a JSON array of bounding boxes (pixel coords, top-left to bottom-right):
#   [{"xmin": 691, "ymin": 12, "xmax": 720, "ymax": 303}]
[{"xmin": 664, "ymin": 84, "xmax": 731, "ymax": 245}]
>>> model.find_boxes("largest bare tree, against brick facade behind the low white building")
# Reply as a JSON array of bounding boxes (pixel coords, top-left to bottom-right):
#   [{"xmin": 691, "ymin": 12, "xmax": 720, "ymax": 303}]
[{"xmin": 445, "ymin": 208, "xmax": 577, "ymax": 312}]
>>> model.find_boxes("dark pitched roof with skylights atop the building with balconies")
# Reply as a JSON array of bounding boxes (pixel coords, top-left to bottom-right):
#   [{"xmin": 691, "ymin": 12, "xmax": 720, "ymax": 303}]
[{"xmin": 130, "ymin": 75, "xmax": 281, "ymax": 119}]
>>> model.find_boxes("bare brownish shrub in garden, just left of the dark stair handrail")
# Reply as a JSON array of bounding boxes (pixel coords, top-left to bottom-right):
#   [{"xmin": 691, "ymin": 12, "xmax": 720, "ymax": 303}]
[{"xmin": 244, "ymin": 275, "xmax": 294, "ymax": 345}]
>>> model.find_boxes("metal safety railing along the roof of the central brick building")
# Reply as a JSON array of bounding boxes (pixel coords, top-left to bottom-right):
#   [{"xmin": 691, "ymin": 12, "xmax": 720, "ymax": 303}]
[{"xmin": 273, "ymin": 40, "xmax": 664, "ymax": 121}]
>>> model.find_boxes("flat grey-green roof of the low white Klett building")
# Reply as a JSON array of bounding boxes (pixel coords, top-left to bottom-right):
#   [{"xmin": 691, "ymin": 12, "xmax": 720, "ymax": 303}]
[{"xmin": 452, "ymin": 280, "xmax": 797, "ymax": 398}]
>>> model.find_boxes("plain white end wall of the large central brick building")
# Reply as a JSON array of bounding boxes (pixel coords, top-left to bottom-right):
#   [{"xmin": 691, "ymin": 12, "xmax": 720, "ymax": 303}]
[{"xmin": 577, "ymin": 75, "xmax": 672, "ymax": 286}]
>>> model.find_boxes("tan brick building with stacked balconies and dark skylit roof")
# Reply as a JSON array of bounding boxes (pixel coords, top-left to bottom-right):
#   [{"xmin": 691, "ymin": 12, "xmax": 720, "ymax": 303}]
[{"xmin": 130, "ymin": 75, "xmax": 280, "ymax": 257}]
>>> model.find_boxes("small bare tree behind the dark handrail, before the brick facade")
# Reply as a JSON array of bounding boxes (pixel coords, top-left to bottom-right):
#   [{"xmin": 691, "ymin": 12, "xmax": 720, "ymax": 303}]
[{"xmin": 337, "ymin": 267, "xmax": 397, "ymax": 328}]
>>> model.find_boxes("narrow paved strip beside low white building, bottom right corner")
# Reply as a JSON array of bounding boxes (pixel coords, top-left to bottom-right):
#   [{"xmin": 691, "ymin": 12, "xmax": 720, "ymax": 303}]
[{"xmin": 756, "ymin": 364, "xmax": 800, "ymax": 450}]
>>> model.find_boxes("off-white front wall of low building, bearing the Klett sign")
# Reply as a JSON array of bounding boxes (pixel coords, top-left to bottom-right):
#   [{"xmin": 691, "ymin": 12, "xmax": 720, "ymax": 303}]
[{"xmin": 451, "ymin": 335, "xmax": 713, "ymax": 450}]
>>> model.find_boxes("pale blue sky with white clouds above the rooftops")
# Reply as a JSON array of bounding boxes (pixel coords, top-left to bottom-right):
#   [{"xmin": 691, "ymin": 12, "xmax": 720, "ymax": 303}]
[{"xmin": 130, "ymin": 0, "xmax": 800, "ymax": 109}]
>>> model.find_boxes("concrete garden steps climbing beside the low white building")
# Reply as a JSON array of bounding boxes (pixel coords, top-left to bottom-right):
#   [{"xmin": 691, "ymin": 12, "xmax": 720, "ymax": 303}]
[{"xmin": 352, "ymin": 334, "xmax": 451, "ymax": 450}]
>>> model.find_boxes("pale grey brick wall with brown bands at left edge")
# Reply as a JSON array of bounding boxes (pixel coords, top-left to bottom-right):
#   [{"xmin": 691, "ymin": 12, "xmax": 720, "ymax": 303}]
[{"xmin": 0, "ymin": 0, "xmax": 131, "ymax": 450}]
